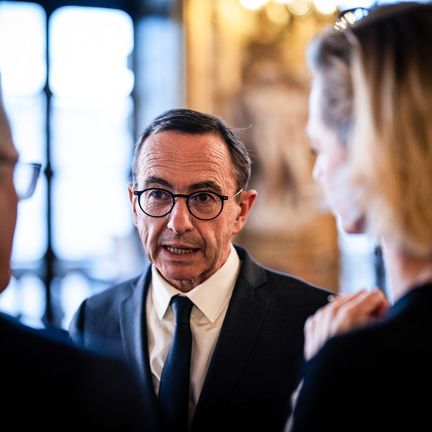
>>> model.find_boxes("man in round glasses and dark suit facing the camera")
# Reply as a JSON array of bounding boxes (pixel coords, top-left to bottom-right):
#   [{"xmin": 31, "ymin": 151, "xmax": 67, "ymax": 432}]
[{"xmin": 70, "ymin": 109, "xmax": 328, "ymax": 432}]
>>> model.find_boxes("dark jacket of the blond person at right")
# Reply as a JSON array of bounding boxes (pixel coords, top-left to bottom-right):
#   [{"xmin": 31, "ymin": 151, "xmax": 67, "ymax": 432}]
[{"xmin": 293, "ymin": 285, "xmax": 432, "ymax": 432}]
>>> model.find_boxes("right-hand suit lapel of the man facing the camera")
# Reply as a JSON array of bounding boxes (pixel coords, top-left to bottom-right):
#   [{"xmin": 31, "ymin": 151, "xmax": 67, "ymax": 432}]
[{"xmin": 192, "ymin": 248, "xmax": 268, "ymax": 430}]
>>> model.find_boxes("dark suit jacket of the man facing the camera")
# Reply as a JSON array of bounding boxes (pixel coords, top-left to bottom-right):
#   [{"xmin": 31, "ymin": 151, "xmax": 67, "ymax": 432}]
[{"xmin": 70, "ymin": 247, "xmax": 329, "ymax": 432}]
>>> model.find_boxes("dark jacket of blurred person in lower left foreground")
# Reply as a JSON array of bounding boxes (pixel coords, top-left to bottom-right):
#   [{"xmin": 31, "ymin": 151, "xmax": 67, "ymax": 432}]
[{"xmin": 0, "ymin": 314, "xmax": 143, "ymax": 432}]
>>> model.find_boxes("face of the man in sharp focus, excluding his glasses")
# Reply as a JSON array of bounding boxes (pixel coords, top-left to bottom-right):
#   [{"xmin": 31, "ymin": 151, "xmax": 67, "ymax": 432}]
[{"xmin": 129, "ymin": 131, "xmax": 256, "ymax": 292}]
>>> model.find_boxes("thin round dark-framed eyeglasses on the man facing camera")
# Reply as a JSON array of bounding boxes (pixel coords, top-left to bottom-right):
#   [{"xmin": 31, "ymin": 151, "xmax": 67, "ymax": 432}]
[{"xmin": 134, "ymin": 188, "xmax": 243, "ymax": 220}]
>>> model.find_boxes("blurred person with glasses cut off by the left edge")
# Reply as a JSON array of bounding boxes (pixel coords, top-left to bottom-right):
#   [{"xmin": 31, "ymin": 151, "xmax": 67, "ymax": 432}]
[{"xmin": 0, "ymin": 78, "xmax": 149, "ymax": 432}]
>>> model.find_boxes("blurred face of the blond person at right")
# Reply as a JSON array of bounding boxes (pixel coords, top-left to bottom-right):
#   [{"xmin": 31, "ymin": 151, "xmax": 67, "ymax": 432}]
[{"xmin": 307, "ymin": 78, "xmax": 365, "ymax": 234}]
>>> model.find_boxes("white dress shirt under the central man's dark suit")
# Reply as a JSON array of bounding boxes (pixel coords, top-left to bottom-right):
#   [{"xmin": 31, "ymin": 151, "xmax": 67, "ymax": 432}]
[{"xmin": 146, "ymin": 245, "xmax": 240, "ymax": 418}]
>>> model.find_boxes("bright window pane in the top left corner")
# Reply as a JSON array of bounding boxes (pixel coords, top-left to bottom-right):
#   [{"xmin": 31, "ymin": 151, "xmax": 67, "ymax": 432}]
[{"xmin": 0, "ymin": 1, "xmax": 46, "ymax": 95}]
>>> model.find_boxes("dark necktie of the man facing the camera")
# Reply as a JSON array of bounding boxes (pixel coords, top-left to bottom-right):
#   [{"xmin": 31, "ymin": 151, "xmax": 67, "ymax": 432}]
[{"xmin": 159, "ymin": 296, "xmax": 193, "ymax": 432}]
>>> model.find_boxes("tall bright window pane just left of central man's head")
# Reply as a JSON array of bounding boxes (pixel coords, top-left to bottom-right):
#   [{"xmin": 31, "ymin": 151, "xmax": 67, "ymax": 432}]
[{"xmin": 50, "ymin": 7, "xmax": 137, "ymax": 279}]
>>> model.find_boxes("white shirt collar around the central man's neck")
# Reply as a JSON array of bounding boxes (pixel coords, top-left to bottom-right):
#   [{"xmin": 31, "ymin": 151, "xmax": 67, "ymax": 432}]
[{"xmin": 152, "ymin": 244, "xmax": 240, "ymax": 323}]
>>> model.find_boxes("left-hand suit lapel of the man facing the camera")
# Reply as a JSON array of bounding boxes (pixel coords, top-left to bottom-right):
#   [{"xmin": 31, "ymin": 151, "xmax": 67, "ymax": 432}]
[{"xmin": 120, "ymin": 266, "xmax": 158, "ymax": 431}]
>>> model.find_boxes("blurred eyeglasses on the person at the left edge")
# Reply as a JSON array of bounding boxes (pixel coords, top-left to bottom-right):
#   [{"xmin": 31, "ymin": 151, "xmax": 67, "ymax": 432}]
[{"xmin": 0, "ymin": 156, "xmax": 42, "ymax": 200}]
